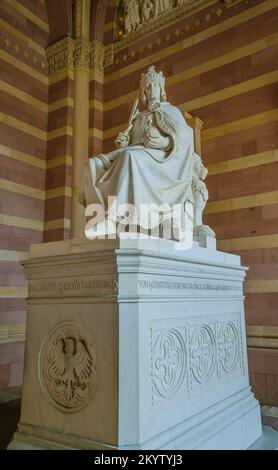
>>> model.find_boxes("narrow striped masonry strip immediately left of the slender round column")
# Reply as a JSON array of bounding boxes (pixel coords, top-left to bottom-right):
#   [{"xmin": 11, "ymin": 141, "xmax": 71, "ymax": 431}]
[{"xmin": 44, "ymin": 44, "xmax": 74, "ymax": 242}]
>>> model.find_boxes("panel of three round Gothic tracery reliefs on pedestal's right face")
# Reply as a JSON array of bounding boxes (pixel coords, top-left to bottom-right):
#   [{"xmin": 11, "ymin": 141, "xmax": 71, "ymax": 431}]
[{"xmin": 150, "ymin": 314, "xmax": 244, "ymax": 411}]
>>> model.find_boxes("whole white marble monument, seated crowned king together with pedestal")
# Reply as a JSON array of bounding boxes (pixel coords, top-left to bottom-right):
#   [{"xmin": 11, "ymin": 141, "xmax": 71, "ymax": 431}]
[{"xmin": 9, "ymin": 66, "xmax": 260, "ymax": 458}]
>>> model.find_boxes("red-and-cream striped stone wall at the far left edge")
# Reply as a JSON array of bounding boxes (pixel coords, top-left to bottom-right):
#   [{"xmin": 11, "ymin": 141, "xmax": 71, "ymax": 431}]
[{"xmin": 0, "ymin": 0, "xmax": 48, "ymax": 388}]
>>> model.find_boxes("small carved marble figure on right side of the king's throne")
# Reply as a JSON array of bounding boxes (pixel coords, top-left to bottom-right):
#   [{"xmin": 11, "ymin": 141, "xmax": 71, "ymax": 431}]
[{"xmin": 192, "ymin": 152, "xmax": 215, "ymax": 237}]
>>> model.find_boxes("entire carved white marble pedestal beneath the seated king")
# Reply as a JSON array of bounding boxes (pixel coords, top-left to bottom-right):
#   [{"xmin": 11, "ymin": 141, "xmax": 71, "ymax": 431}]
[{"xmin": 9, "ymin": 239, "xmax": 261, "ymax": 449}]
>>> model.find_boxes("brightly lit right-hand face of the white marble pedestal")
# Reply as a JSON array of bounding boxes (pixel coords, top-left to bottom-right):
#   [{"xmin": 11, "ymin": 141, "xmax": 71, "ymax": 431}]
[{"xmin": 113, "ymin": 240, "xmax": 261, "ymax": 449}]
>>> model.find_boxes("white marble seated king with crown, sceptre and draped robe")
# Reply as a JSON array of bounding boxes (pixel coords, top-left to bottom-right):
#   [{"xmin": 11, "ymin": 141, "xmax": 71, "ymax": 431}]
[{"xmin": 84, "ymin": 66, "xmax": 194, "ymax": 238}]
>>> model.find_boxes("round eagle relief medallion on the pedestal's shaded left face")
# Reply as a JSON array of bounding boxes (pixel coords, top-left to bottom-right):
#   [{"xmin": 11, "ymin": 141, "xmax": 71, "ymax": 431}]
[{"xmin": 39, "ymin": 322, "xmax": 97, "ymax": 412}]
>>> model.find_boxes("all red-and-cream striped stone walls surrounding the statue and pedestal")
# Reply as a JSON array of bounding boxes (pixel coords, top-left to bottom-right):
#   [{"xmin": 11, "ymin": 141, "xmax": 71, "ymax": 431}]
[{"xmin": 0, "ymin": 0, "xmax": 278, "ymax": 404}]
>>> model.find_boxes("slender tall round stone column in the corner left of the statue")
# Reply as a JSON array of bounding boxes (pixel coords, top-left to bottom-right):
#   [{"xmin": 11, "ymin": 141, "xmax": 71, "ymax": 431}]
[{"xmin": 71, "ymin": 0, "xmax": 91, "ymax": 238}]
